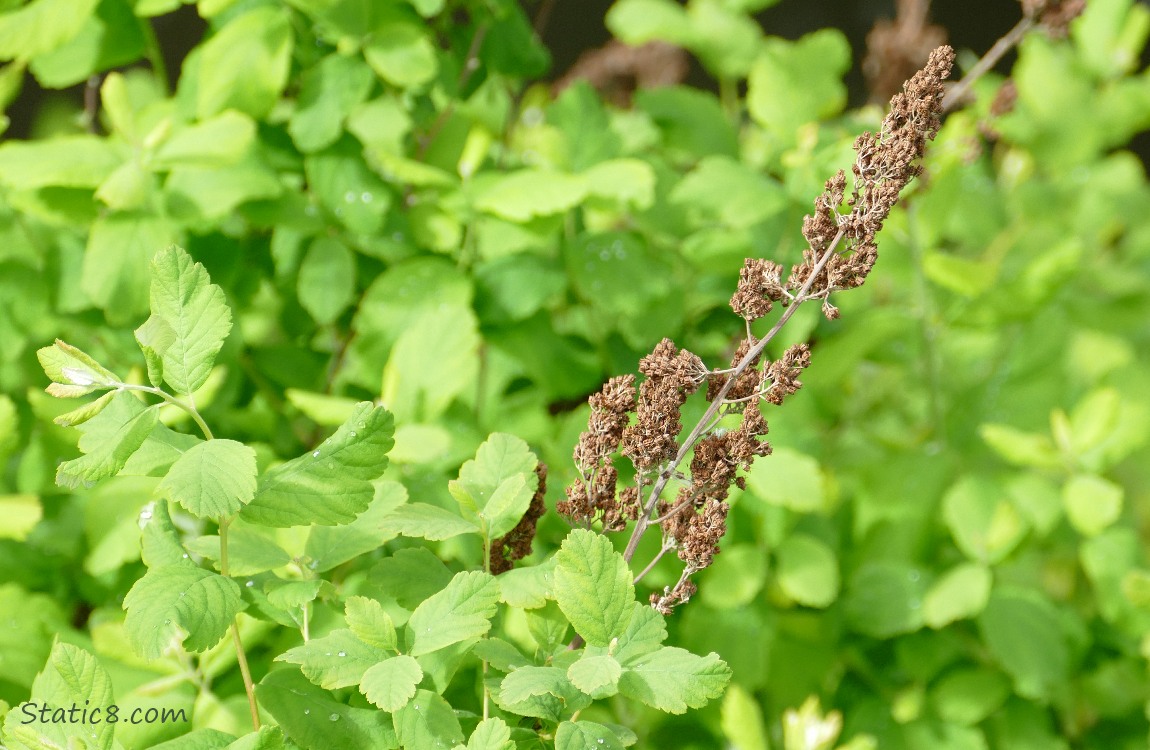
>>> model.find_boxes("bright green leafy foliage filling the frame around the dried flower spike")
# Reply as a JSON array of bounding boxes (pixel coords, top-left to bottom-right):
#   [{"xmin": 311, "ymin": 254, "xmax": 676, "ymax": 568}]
[{"xmin": 0, "ymin": 0, "xmax": 1150, "ymax": 750}]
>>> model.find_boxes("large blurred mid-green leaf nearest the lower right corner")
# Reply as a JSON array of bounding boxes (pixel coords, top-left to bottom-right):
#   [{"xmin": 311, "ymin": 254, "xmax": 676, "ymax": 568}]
[{"xmin": 979, "ymin": 589, "xmax": 1071, "ymax": 701}]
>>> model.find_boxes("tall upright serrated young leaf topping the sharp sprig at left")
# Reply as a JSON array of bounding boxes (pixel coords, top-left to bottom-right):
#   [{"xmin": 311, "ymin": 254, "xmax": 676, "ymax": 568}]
[{"xmin": 137, "ymin": 246, "xmax": 231, "ymax": 393}]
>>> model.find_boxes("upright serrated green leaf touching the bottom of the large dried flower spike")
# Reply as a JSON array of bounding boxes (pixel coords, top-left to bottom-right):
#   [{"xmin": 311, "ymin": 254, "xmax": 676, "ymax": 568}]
[{"xmin": 555, "ymin": 529, "xmax": 635, "ymax": 646}]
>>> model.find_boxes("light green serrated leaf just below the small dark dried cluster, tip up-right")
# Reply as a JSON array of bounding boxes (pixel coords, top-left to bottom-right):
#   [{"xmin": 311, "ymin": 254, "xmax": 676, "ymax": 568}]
[{"xmin": 407, "ymin": 571, "xmax": 499, "ymax": 656}]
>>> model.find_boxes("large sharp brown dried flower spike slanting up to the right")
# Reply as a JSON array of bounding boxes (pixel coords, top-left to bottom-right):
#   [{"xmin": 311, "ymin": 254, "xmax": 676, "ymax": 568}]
[{"xmin": 559, "ymin": 47, "xmax": 955, "ymax": 614}]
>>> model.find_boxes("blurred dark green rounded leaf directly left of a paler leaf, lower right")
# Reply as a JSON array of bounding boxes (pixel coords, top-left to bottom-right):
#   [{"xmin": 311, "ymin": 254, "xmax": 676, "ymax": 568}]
[{"xmin": 845, "ymin": 561, "xmax": 926, "ymax": 638}]
